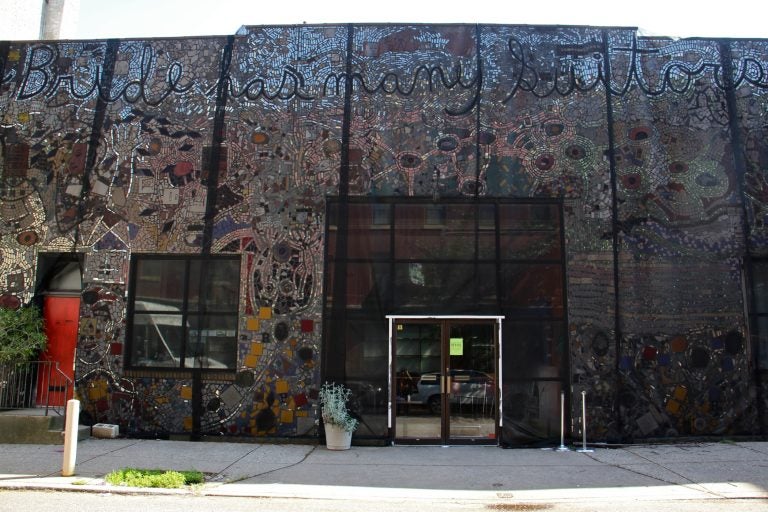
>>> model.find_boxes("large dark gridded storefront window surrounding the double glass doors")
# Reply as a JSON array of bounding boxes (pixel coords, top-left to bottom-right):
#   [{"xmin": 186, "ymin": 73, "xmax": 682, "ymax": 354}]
[{"xmin": 323, "ymin": 198, "xmax": 568, "ymax": 442}]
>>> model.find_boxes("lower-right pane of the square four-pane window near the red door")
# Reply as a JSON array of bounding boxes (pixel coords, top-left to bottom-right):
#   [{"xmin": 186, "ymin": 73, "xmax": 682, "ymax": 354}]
[{"xmin": 184, "ymin": 315, "xmax": 237, "ymax": 369}]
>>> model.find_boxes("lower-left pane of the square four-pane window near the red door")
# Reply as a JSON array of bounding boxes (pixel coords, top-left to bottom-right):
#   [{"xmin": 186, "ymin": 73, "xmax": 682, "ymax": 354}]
[{"xmin": 131, "ymin": 310, "xmax": 184, "ymax": 368}]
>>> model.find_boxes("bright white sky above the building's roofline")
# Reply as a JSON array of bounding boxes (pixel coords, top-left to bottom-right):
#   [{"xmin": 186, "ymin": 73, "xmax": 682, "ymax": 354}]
[{"xmin": 77, "ymin": 0, "xmax": 768, "ymax": 39}]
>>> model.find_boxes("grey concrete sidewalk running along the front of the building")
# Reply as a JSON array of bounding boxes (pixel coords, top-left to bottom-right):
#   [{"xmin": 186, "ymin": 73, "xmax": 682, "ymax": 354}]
[{"xmin": 0, "ymin": 439, "xmax": 768, "ymax": 502}]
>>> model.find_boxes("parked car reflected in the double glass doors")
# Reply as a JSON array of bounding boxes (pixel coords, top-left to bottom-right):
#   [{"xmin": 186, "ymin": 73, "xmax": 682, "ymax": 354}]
[{"xmin": 398, "ymin": 369, "xmax": 495, "ymax": 414}]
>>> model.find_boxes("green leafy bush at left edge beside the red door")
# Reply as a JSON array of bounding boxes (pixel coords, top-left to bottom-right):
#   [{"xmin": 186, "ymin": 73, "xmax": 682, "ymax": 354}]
[{"xmin": 0, "ymin": 306, "xmax": 48, "ymax": 364}]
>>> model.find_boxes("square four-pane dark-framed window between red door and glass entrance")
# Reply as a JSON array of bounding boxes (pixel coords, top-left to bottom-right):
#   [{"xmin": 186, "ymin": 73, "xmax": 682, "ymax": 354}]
[{"xmin": 128, "ymin": 255, "xmax": 240, "ymax": 369}]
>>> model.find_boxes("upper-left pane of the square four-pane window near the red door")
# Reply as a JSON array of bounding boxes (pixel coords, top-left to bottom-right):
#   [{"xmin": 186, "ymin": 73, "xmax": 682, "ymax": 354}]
[{"xmin": 135, "ymin": 258, "xmax": 185, "ymax": 308}]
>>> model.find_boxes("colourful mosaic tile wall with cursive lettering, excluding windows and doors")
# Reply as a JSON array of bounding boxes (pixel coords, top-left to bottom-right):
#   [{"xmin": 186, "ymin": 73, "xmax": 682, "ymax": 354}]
[{"xmin": 0, "ymin": 25, "xmax": 768, "ymax": 440}]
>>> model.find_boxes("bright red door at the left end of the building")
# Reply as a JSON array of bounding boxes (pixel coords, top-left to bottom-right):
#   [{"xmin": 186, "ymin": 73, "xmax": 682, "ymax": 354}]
[{"xmin": 37, "ymin": 295, "xmax": 80, "ymax": 406}]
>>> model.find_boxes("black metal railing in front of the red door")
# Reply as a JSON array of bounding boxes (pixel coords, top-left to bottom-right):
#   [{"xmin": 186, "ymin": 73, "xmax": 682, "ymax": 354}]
[{"xmin": 0, "ymin": 361, "xmax": 74, "ymax": 416}]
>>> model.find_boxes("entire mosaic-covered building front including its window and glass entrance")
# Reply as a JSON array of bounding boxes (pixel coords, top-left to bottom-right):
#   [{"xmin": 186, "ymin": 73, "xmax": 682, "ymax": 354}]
[{"xmin": 0, "ymin": 25, "xmax": 768, "ymax": 445}]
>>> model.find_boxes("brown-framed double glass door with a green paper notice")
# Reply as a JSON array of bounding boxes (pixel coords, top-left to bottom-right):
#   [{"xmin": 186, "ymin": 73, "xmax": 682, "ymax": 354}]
[{"xmin": 391, "ymin": 318, "xmax": 500, "ymax": 444}]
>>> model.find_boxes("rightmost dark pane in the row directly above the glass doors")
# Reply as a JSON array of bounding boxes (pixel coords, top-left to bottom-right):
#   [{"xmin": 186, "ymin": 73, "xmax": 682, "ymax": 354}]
[{"xmin": 501, "ymin": 264, "xmax": 564, "ymax": 318}]
